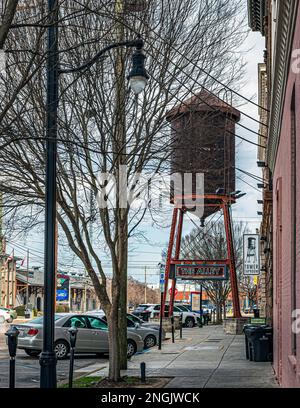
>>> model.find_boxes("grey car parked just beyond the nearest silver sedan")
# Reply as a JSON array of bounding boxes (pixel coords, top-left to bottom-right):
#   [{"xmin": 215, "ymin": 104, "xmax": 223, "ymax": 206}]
[{"xmin": 87, "ymin": 310, "xmax": 166, "ymax": 349}]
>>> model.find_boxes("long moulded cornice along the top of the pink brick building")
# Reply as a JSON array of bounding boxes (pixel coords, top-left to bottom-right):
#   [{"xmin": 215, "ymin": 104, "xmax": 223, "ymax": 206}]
[{"xmin": 267, "ymin": 0, "xmax": 299, "ymax": 173}]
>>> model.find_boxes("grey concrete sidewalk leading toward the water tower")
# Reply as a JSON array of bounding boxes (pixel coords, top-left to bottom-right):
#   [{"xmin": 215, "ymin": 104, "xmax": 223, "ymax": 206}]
[{"xmin": 77, "ymin": 326, "xmax": 278, "ymax": 388}]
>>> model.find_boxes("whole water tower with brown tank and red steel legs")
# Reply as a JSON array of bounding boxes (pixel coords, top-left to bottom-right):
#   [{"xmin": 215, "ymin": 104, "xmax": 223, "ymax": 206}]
[{"xmin": 162, "ymin": 90, "xmax": 240, "ymax": 317}]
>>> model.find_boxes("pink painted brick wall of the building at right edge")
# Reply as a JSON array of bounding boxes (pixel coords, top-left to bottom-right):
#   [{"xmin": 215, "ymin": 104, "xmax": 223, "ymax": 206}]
[{"xmin": 273, "ymin": 2, "xmax": 300, "ymax": 387}]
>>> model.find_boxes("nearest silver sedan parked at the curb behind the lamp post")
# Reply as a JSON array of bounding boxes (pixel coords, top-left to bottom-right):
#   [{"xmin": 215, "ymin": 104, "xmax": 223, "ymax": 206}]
[{"xmin": 14, "ymin": 313, "xmax": 144, "ymax": 360}]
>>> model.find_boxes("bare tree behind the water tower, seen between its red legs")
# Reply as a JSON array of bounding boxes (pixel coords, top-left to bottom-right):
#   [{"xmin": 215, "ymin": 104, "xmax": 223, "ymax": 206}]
[{"xmin": 182, "ymin": 221, "xmax": 248, "ymax": 323}]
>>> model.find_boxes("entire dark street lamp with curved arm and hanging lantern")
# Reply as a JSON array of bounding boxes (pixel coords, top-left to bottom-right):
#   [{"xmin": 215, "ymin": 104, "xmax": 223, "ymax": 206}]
[{"xmin": 40, "ymin": 0, "xmax": 149, "ymax": 388}]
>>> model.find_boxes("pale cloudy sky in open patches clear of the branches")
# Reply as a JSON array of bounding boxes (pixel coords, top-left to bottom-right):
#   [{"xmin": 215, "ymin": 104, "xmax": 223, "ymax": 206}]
[{"xmin": 7, "ymin": 6, "xmax": 264, "ymax": 284}]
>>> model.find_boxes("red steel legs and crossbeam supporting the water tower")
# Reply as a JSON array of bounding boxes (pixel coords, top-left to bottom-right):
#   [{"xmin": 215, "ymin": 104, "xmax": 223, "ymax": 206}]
[{"xmin": 161, "ymin": 195, "xmax": 241, "ymax": 318}]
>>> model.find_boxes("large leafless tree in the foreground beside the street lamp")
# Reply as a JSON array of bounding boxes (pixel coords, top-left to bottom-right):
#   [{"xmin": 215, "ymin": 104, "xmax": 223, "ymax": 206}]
[{"xmin": 0, "ymin": 0, "xmax": 245, "ymax": 380}]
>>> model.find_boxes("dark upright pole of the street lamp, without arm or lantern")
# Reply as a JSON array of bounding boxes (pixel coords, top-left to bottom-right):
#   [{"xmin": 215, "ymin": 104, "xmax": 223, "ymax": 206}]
[{"xmin": 40, "ymin": 0, "xmax": 59, "ymax": 388}]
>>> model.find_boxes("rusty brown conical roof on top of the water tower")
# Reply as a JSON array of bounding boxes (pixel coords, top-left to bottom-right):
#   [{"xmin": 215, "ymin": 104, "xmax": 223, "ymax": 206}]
[{"xmin": 166, "ymin": 90, "xmax": 241, "ymax": 122}]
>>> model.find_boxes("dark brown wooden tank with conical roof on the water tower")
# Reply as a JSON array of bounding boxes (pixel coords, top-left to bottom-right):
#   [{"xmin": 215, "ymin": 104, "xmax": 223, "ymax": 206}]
[{"xmin": 166, "ymin": 91, "xmax": 240, "ymax": 218}]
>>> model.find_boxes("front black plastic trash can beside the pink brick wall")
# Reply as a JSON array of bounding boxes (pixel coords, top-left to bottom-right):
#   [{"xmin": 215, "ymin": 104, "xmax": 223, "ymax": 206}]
[{"xmin": 248, "ymin": 326, "xmax": 273, "ymax": 362}]
